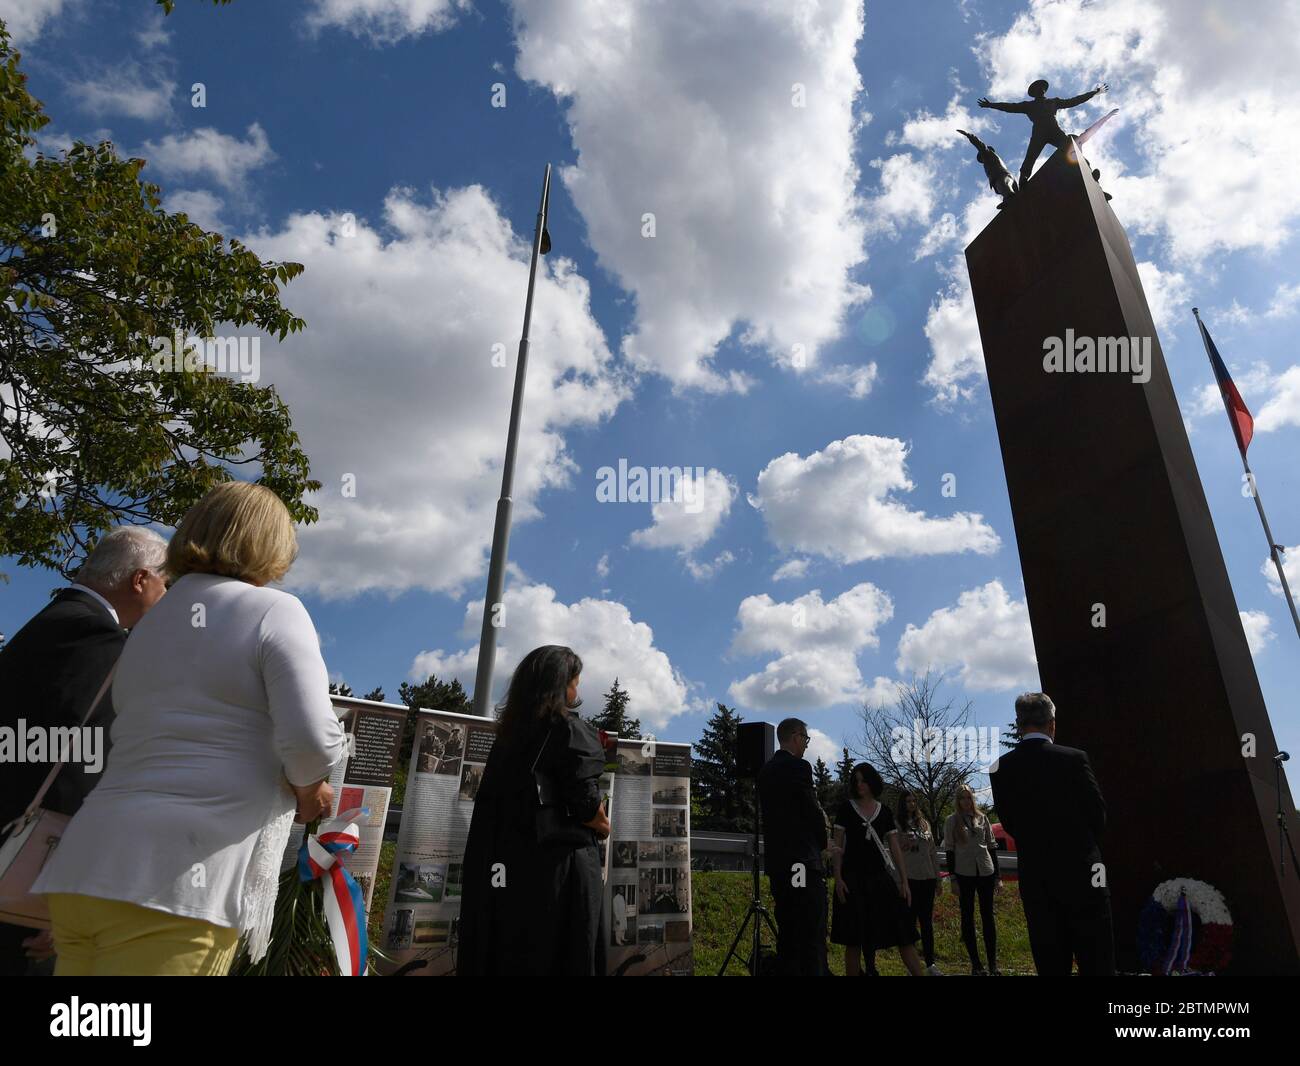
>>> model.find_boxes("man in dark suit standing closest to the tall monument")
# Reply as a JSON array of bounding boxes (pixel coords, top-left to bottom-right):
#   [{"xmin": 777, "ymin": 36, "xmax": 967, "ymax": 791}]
[{"xmin": 989, "ymin": 692, "xmax": 1115, "ymax": 976}]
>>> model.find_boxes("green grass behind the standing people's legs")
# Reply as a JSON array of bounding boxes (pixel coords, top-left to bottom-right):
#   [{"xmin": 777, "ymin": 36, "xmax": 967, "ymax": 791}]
[{"xmin": 368, "ymin": 841, "xmax": 1034, "ymax": 976}]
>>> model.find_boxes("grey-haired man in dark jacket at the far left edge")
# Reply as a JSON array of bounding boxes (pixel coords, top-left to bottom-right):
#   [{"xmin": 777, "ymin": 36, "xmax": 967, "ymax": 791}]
[{"xmin": 0, "ymin": 525, "xmax": 166, "ymax": 975}]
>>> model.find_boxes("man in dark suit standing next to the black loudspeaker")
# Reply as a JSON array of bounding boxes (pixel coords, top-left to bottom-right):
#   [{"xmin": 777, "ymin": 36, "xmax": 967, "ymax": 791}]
[{"xmin": 758, "ymin": 718, "xmax": 827, "ymax": 978}]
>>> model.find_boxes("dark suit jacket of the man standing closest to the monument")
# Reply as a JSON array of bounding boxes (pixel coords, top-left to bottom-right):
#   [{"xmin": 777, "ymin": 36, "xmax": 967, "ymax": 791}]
[{"xmin": 989, "ymin": 740, "xmax": 1110, "ymax": 901}]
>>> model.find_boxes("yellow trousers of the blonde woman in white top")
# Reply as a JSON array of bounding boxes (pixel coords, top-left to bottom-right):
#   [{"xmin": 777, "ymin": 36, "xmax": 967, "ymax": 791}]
[{"xmin": 46, "ymin": 892, "xmax": 239, "ymax": 978}]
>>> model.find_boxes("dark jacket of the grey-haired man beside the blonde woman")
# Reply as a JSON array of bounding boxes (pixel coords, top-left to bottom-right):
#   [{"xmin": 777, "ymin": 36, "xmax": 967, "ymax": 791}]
[{"xmin": 0, "ymin": 589, "xmax": 126, "ymax": 827}]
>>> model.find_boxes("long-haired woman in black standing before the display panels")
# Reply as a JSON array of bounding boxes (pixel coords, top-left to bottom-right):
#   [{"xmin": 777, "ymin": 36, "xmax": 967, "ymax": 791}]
[{"xmin": 456, "ymin": 645, "xmax": 610, "ymax": 976}]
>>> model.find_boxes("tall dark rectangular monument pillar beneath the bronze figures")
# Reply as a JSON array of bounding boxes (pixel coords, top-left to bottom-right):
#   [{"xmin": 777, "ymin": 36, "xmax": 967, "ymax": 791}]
[{"xmin": 966, "ymin": 137, "xmax": 1300, "ymax": 974}]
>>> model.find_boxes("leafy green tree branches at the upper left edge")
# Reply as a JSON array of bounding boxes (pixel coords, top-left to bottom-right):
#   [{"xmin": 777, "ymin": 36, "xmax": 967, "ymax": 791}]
[{"xmin": 0, "ymin": 23, "xmax": 321, "ymax": 576}]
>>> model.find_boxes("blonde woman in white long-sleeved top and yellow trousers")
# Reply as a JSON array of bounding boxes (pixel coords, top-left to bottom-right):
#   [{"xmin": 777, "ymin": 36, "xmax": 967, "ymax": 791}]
[{"xmin": 34, "ymin": 482, "xmax": 345, "ymax": 975}]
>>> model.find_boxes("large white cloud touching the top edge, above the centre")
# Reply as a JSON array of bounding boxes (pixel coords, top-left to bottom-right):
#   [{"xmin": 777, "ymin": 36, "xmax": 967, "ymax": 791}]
[{"xmin": 512, "ymin": 0, "xmax": 868, "ymax": 391}]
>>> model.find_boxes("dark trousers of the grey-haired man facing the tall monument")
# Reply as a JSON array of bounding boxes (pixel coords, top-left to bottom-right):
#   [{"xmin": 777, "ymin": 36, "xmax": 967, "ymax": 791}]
[{"xmin": 1021, "ymin": 876, "xmax": 1115, "ymax": 978}]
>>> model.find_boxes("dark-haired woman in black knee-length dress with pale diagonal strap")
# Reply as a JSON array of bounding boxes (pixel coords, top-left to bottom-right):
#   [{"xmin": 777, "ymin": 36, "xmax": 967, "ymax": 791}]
[{"xmin": 831, "ymin": 763, "xmax": 926, "ymax": 978}]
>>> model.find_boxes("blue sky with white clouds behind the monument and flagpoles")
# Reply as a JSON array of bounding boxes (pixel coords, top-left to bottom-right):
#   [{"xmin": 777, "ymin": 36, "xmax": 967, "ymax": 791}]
[{"xmin": 0, "ymin": 0, "xmax": 1300, "ymax": 795}]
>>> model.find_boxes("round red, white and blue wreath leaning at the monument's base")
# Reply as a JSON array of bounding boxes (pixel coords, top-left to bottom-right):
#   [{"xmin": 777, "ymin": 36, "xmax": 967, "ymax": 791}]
[{"xmin": 1138, "ymin": 878, "xmax": 1232, "ymax": 975}]
